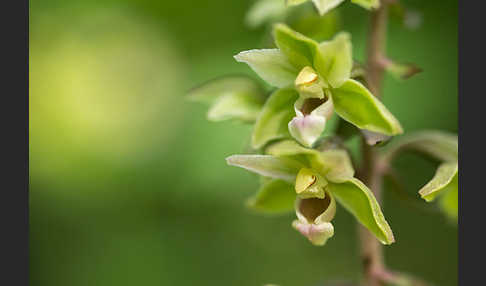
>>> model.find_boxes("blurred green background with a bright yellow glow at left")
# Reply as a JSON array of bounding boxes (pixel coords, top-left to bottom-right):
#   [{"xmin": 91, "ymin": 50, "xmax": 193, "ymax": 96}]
[{"xmin": 30, "ymin": 0, "xmax": 457, "ymax": 286}]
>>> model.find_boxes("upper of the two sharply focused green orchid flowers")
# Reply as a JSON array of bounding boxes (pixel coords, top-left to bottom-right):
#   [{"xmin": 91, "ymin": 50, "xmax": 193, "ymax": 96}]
[{"xmin": 235, "ymin": 24, "xmax": 403, "ymax": 148}]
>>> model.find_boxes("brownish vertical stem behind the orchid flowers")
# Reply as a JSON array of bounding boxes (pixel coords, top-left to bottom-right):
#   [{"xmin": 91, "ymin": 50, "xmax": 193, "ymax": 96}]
[{"xmin": 358, "ymin": 1, "xmax": 387, "ymax": 286}]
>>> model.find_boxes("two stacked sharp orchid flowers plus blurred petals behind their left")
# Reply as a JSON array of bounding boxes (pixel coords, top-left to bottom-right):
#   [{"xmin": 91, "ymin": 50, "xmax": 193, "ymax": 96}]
[{"xmin": 190, "ymin": 24, "xmax": 402, "ymax": 245}]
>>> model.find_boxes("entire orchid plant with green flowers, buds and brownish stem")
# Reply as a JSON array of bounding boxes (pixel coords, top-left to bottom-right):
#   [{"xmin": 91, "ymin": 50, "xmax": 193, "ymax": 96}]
[{"xmin": 189, "ymin": 0, "xmax": 458, "ymax": 285}]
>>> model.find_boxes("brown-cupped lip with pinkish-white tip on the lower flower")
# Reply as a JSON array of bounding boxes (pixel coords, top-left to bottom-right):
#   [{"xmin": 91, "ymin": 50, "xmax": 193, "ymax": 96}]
[{"xmin": 292, "ymin": 194, "xmax": 336, "ymax": 246}]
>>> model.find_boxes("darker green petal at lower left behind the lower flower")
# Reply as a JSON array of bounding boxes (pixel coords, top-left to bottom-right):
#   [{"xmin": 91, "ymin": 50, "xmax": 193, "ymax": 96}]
[{"xmin": 247, "ymin": 179, "xmax": 296, "ymax": 214}]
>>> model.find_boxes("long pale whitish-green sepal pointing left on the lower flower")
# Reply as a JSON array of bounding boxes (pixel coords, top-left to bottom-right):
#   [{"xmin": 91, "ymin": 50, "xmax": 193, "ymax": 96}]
[{"xmin": 226, "ymin": 155, "xmax": 303, "ymax": 183}]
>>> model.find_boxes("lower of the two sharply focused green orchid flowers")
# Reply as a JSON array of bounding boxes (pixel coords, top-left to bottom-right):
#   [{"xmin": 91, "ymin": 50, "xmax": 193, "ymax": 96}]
[{"xmin": 227, "ymin": 140, "xmax": 394, "ymax": 245}]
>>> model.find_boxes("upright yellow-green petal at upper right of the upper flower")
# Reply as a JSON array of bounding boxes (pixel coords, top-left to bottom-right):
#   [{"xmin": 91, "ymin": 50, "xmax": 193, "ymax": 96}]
[{"xmin": 314, "ymin": 32, "xmax": 353, "ymax": 88}]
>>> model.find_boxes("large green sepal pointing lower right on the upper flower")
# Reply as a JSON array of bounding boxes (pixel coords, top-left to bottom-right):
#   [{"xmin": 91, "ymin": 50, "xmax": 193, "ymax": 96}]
[{"xmin": 331, "ymin": 79, "xmax": 403, "ymax": 136}]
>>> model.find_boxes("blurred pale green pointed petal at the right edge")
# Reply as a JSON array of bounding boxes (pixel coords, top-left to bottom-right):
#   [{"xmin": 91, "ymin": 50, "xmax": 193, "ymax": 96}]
[{"xmin": 419, "ymin": 162, "xmax": 458, "ymax": 202}]
